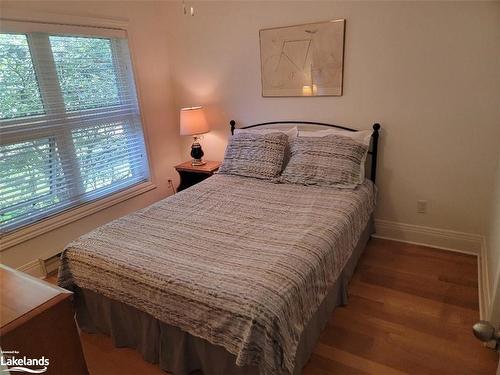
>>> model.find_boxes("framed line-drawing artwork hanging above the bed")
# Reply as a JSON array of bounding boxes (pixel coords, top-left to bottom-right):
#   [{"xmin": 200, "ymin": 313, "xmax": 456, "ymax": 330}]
[{"xmin": 259, "ymin": 19, "xmax": 345, "ymax": 97}]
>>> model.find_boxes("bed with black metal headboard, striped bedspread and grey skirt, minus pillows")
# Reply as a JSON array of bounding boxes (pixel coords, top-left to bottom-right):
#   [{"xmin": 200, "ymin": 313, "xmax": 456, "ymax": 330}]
[{"xmin": 59, "ymin": 121, "xmax": 380, "ymax": 374}]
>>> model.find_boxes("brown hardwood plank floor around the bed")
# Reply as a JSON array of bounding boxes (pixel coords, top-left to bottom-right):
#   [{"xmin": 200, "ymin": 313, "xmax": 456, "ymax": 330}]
[{"xmin": 48, "ymin": 239, "xmax": 498, "ymax": 375}]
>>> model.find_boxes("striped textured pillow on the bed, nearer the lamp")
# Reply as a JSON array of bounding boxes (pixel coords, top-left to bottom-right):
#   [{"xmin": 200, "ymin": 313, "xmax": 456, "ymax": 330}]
[{"xmin": 219, "ymin": 132, "xmax": 288, "ymax": 179}]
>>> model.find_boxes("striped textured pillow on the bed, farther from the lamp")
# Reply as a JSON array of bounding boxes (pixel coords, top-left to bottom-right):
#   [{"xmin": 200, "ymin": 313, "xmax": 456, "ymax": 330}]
[{"xmin": 280, "ymin": 134, "xmax": 368, "ymax": 188}]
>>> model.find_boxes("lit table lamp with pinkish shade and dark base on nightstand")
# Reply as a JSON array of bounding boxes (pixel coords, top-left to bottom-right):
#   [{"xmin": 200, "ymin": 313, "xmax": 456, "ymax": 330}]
[{"xmin": 180, "ymin": 107, "xmax": 209, "ymax": 165}]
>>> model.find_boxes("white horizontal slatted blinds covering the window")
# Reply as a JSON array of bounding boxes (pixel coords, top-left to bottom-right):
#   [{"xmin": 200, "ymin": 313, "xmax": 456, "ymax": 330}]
[{"xmin": 0, "ymin": 25, "xmax": 149, "ymax": 234}]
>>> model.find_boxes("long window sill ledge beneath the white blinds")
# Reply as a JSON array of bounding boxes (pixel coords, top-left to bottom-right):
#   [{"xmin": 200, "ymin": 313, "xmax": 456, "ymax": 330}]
[{"xmin": 0, "ymin": 181, "xmax": 156, "ymax": 252}]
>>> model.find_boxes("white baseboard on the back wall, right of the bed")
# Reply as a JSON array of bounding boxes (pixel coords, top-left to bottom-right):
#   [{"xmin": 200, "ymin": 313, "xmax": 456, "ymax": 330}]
[{"xmin": 373, "ymin": 220, "xmax": 482, "ymax": 255}]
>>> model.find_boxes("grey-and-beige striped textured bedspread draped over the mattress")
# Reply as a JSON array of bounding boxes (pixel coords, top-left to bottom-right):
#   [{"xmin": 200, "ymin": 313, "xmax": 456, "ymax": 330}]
[{"xmin": 59, "ymin": 175, "xmax": 374, "ymax": 373}]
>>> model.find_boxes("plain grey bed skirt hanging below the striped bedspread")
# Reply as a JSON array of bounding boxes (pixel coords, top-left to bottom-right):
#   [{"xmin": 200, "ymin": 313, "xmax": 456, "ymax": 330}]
[{"xmin": 75, "ymin": 219, "xmax": 374, "ymax": 375}]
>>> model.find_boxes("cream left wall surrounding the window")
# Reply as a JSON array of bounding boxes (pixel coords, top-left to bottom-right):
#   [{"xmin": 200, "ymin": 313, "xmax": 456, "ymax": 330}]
[{"xmin": 0, "ymin": 1, "xmax": 180, "ymax": 267}]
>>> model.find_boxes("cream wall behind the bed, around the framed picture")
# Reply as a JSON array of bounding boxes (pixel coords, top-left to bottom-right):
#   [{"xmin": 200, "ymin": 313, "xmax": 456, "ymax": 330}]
[{"xmin": 167, "ymin": 1, "xmax": 500, "ymax": 244}]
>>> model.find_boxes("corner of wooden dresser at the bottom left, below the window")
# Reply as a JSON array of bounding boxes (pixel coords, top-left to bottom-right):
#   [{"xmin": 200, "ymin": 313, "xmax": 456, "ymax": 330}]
[{"xmin": 0, "ymin": 264, "xmax": 88, "ymax": 375}]
